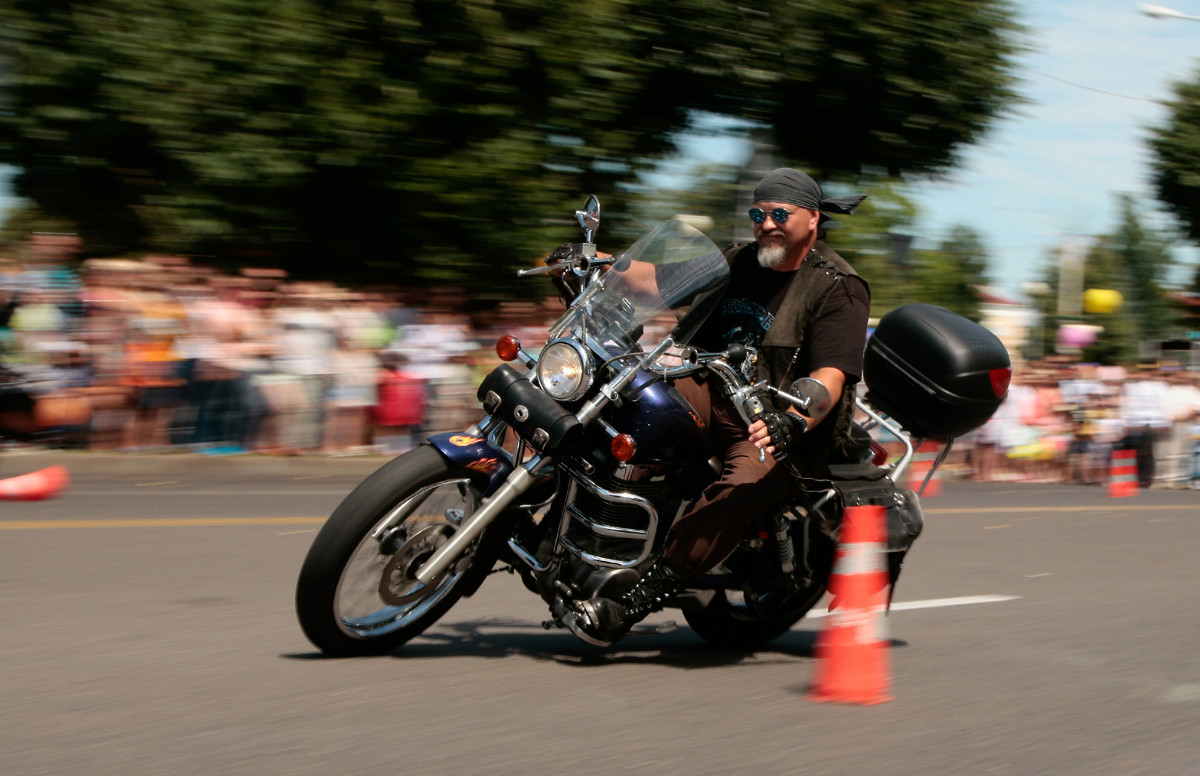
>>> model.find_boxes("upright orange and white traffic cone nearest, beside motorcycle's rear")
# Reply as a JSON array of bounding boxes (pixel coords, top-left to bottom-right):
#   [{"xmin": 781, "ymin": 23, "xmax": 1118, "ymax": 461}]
[{"xmin": 809, "ymin": 505, "xmax": 892, "ymax": 706}]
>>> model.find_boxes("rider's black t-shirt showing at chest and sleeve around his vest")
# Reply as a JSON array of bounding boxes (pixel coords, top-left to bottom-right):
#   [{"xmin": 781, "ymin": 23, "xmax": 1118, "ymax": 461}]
[{"xmin": 696, "ymin": 254, "xmax": 870, "ymax": 383}]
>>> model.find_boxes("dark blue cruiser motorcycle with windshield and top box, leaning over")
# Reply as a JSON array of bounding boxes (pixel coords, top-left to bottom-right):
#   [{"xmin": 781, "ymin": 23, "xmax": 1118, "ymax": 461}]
[{"xmin": 296, "ymin": 197, "xmax": 1010, "ymax": 655}]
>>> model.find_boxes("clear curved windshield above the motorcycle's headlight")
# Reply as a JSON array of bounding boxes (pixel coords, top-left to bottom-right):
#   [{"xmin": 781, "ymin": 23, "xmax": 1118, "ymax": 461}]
[{"xmin": 551, "ymin": 221, "xmax": 730, "ymax": 348}]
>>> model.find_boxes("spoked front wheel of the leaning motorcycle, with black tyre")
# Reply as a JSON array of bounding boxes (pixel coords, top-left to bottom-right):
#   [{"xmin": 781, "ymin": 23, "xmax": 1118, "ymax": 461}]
[{"xmin": 296, "ymin": 445, "xmax": 496, "ymax": 656}]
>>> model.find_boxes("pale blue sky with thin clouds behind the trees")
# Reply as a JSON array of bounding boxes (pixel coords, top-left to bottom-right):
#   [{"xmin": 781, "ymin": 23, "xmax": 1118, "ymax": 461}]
[{"xmin": 0, "ymin": 0, "xmax": 1200, "ymax": 299}]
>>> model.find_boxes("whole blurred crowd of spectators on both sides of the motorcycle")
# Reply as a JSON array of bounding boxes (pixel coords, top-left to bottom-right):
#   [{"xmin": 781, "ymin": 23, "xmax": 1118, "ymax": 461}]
[{"xmin": 0, "ymin": 235, "xmax": 1200, "ymax": 486}]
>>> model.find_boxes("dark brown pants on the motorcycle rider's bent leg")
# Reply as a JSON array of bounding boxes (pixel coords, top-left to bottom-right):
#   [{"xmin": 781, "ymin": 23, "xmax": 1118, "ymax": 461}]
[{"xmin": 662, "ymin": 379, "xmax": 794, "ymax": 581}]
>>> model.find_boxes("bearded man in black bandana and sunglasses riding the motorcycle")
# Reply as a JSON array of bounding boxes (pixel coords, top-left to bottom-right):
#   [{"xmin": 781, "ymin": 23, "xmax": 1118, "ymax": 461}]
[{"xmin": 563, "ymin": 168, "xmax": 870, "ymax": 646}]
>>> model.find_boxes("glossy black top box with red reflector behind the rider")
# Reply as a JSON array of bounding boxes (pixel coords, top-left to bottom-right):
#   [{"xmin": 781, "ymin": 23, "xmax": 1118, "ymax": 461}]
[{"xmin": 863, "ymin": 305, "xmax": 1013, "ymax": 439}]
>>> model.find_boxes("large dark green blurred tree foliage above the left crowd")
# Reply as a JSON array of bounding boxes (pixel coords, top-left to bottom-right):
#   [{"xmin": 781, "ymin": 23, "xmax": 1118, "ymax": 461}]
[{"xmin": 0, "ymin": 0, "xmax": 1020, "ymax": 293}]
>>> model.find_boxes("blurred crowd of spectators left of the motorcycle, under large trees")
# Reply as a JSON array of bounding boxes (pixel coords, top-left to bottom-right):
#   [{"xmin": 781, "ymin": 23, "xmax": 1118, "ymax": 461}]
[{"xmin": 0, "ymin": 235, "xmax": 556, "ymax": 453}]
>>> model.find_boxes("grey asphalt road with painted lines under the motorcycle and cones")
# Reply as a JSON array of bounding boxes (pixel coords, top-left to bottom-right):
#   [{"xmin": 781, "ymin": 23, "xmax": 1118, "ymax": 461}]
[{"xmin": 0, "ymin": 453, "xmax": 1200, "ymax": 776}]
